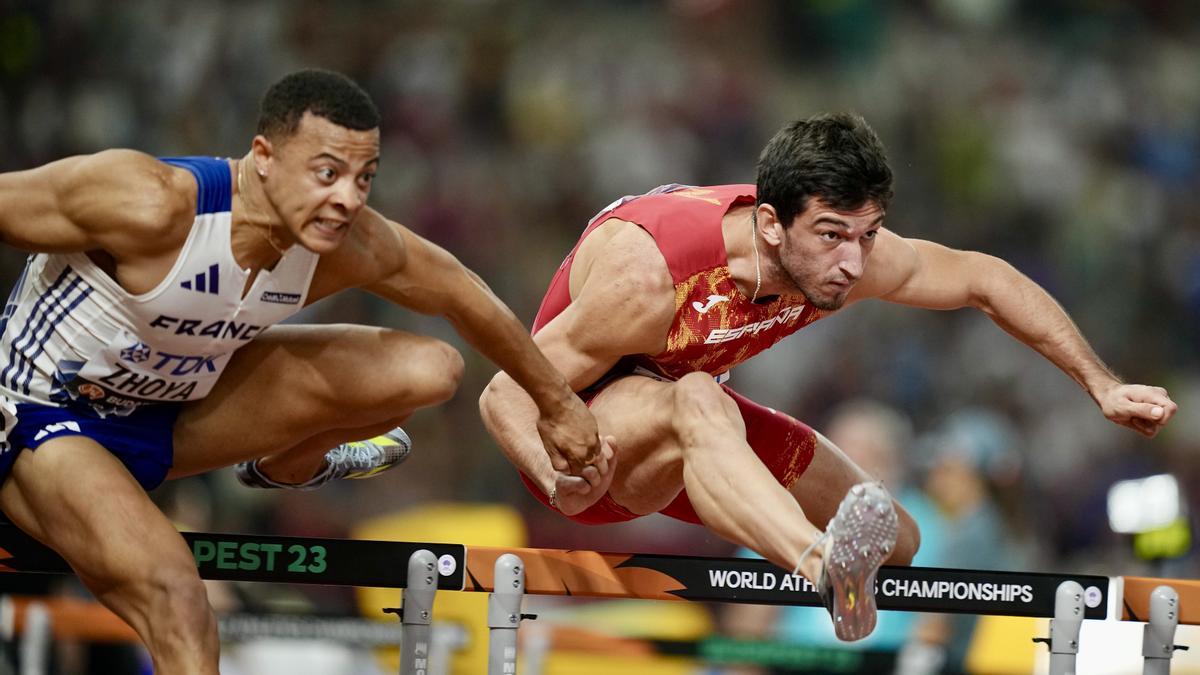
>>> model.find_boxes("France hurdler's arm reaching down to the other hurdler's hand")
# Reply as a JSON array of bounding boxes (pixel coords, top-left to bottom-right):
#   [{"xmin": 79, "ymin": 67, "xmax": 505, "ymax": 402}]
[{"xmin": 366, "ymin": 223, "xmax": 600, "ymax": 467}]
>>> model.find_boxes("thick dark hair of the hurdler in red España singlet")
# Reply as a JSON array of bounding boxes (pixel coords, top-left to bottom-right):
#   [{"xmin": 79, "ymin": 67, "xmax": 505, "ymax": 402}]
[{"xmin": 756, "ymin": 113, "xmax": 892, "ymax": 227}]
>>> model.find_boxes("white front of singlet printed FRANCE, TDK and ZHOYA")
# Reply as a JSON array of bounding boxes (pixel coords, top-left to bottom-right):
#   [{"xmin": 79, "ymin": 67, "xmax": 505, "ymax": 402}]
[{"xmin": 55, "ymin": 230, "xmax": 316, "ymax": 412}]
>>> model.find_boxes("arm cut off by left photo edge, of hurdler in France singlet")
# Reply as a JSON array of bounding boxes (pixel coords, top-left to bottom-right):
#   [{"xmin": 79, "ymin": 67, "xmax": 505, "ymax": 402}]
[{"xmin": 0, "ymin": 150, "xmax": 188, "ymax": 257}]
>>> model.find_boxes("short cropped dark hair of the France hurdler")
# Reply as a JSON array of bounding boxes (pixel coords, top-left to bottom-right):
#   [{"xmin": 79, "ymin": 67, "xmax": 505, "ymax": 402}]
[{"xmin": 258, "ymin": 68, "xmax": 379, "ymax": 138}]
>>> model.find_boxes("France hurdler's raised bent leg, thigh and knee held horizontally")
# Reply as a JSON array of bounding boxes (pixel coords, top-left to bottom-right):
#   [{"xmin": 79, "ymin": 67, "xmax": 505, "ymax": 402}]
[{"xmin": 169, "ymin": 324, "xmax": 463, "ymax": 483}]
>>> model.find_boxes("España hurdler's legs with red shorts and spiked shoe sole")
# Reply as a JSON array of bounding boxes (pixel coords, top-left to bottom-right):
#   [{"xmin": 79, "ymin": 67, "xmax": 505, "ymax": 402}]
[{"xmin": 592, "ymin": 374, "xmax": 917, "ymax": 640}]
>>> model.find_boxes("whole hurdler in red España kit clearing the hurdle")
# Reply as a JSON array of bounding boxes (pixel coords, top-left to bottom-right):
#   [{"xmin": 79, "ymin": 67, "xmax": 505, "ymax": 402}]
[{"xmin": 480, "ymin": 113, "xmax": 1176, "ymax": 640}]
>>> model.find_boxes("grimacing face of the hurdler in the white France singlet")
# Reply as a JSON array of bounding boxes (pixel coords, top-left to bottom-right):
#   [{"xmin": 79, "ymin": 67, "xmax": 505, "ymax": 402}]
[{"xmin": 259, "ymin": 113, "xmax": 379, "ymax": 253}]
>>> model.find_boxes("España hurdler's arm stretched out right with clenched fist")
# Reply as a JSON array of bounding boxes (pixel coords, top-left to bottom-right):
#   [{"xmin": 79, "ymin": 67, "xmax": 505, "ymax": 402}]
[{"xmin": 856, "ymin": 225, "xmax": 1177, "ymax": 437}]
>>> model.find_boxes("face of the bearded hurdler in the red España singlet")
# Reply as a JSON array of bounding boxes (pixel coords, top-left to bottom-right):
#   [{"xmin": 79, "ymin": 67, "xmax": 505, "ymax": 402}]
[{"xmin": 779, "ymin": 198, "xmax": 883, "ymax": 310}]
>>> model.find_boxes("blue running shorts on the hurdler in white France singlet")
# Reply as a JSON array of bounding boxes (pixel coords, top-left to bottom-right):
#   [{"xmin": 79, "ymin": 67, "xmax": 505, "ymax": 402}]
[{"xmin": 0, "ymin": 395, "xmax": 180, "ymax": 490}]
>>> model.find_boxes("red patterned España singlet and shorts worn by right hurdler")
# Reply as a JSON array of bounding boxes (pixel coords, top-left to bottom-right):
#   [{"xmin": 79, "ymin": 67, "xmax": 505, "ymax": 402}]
[{"xmin": 522, "ymin": 185, "xmax": 828, "ymax": 525}]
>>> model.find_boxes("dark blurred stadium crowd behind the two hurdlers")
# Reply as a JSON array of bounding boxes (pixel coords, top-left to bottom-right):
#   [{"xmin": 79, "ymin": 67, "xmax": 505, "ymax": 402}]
[{"xmin": 0, "ymin": 0, "xmax": 1200, "ymax": 662}]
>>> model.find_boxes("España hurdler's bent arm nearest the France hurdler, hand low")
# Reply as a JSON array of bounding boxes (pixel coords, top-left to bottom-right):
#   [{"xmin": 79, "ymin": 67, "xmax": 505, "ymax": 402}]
[{"xmin": 479, "ymin": 222, "xmax": 674, "ymax": 515}]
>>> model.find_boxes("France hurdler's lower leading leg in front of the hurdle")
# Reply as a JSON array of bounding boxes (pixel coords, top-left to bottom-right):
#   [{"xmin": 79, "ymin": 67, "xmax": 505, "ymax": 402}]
[{"xmin": 0, "ymin": 436, "xmax": 220, "ymax": 675}]
